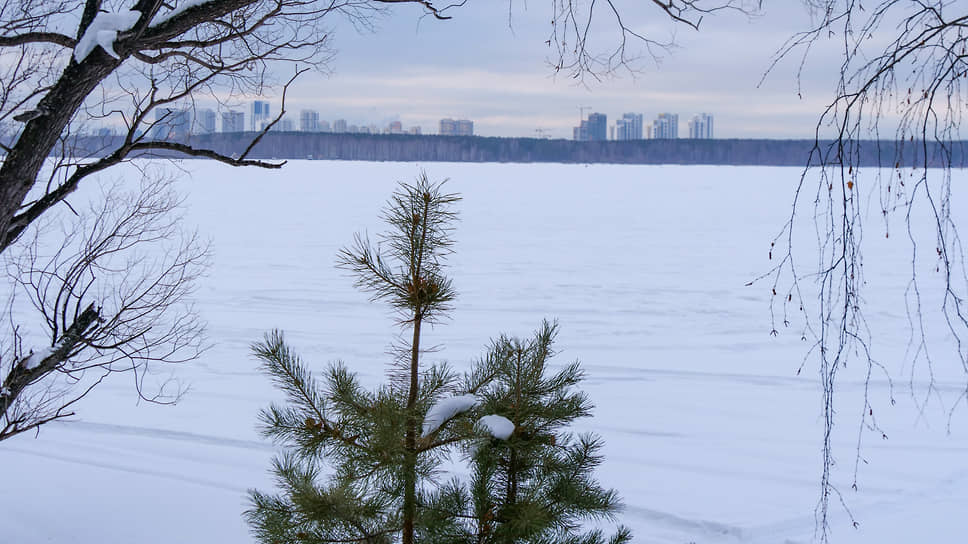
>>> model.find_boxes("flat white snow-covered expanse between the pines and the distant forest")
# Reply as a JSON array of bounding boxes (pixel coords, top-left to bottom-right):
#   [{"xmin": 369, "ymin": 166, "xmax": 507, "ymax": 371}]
[{"xmin": 0, "ymin": 161, "xmax": 968, "ymax": 544}]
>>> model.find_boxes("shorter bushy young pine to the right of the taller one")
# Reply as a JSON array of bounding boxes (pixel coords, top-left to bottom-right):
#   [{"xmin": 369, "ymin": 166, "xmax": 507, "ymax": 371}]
[{"xmin": 422, "ymin": 322, "xmax": 631, "ymax": 544}]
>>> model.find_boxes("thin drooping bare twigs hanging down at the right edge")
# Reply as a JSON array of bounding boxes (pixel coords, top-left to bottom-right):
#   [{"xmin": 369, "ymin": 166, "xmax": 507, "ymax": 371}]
[{"xmin": 756, "ymin": 0, "xmax": 968, "ymax": 542}]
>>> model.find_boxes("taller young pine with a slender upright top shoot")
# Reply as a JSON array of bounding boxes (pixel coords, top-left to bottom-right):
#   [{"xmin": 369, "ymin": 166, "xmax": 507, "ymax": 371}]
[{"xmin": 246, "ymin": 175, "xmax": 484, "ymax": 544}]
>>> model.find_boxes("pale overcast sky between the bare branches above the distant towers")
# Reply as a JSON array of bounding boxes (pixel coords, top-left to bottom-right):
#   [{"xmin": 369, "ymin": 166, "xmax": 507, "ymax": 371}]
[{"xmin": 274, "ymin": 0, "xmax": 838, "ymax": 138}]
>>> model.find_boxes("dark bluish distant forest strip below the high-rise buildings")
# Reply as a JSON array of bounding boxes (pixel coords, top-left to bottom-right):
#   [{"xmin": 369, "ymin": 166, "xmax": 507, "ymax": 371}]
[{"xmin": 70, "ymin": 132, "xmax": 968, "ymax": 168}]
